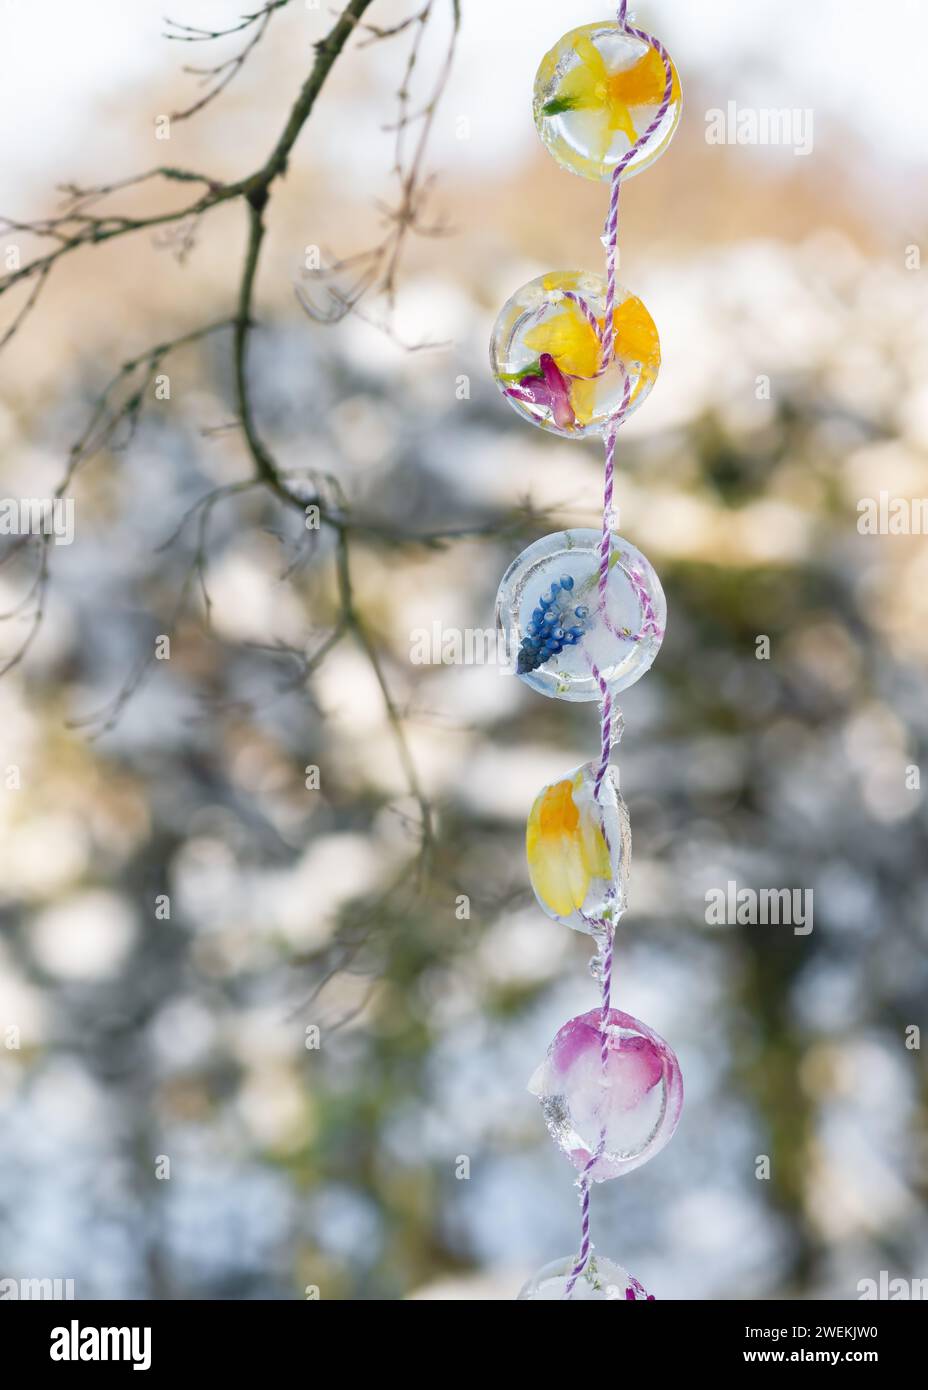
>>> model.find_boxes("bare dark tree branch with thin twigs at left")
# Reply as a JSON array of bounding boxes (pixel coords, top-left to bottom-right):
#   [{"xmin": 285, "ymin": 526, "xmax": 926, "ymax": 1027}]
[{"xmin": 0, "ymin": 0, "xmax": 458, "ymax": 853}]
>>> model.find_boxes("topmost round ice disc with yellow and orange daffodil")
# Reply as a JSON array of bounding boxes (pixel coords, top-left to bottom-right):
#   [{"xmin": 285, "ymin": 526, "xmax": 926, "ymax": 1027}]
[{"xmin": 533, "ymin": 22, "xmax": 682, "ymax": 179}]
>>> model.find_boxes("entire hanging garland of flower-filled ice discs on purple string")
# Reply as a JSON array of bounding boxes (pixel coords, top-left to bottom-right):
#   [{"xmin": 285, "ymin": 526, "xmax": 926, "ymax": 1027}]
[{"xmin": 490, "ymin": 0, "xmax": 683, "ymax": 1302}]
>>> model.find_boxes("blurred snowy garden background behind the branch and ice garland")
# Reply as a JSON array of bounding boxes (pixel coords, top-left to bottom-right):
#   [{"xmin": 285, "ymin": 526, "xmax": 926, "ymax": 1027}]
[{"xmin": 0, "ymin": 0, "xmax": 928, "ymax": 1300}]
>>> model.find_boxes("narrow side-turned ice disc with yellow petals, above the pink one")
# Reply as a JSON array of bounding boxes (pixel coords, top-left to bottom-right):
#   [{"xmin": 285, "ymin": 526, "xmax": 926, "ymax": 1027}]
[{"xmin": 525, "ymin": 763, "xmax": 632, "ymax": 935}]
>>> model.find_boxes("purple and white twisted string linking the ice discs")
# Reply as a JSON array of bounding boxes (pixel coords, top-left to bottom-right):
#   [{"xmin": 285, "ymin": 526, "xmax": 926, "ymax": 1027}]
[{"xmin": 563, "ymin": 0, "xmax": 674, "ymax": 1298}]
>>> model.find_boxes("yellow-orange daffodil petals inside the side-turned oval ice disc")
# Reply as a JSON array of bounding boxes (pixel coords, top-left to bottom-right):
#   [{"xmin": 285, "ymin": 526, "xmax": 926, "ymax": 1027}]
[{"xmin": 525, "ymin": 769, "xmax": 611, "ymax": 917}]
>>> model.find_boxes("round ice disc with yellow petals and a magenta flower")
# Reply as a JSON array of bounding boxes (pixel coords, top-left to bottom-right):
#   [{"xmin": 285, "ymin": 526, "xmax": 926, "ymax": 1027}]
[{"xmin": 490, "ymin": 271, "xmax": 660, "ymax": 439}]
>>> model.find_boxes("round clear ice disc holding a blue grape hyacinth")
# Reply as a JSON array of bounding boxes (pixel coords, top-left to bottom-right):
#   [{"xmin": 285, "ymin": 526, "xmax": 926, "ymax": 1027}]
[{"xmin": 496, "ymin": 530, "xmax": 667, "ymax": 701}]
